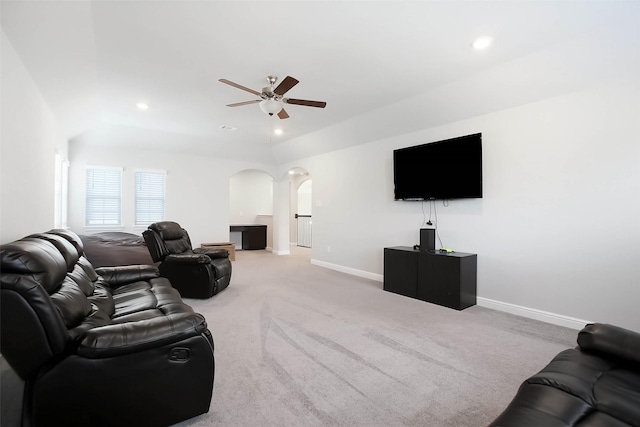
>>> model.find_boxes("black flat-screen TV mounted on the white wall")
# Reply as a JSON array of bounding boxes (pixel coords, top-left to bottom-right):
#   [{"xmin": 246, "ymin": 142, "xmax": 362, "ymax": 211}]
[{"xmin": 393, "ymin": 133, "xmax": 482, "ymax": 200}]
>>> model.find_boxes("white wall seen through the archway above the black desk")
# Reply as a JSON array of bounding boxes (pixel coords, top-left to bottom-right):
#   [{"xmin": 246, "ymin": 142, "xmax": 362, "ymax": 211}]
[{"xmin": 229, "ymin": 170, "xmax": 273, "ymax": 224}]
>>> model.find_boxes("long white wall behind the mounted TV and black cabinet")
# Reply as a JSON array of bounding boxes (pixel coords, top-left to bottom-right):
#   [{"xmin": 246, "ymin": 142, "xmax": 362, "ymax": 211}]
[{"xmin": 288, "ymin": 82, "xmax": 640, "ymax": 330}]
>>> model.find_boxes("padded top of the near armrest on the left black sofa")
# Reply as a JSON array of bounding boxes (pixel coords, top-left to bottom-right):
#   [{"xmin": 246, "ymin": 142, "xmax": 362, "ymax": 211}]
[{"xmin": 77, "ymin": 312, "xmax": 208, "ymax": 359}]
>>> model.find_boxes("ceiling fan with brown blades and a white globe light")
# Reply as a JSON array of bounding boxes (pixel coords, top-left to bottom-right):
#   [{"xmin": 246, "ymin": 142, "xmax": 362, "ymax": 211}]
[{"xmin": 219, "ymin": 76, "xmax": 327, "ymax": 119}]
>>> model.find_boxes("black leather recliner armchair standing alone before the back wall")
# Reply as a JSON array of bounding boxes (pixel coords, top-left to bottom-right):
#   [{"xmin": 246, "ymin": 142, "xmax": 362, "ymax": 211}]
[{"xmin": 142, "ymin": 221, "xmax": 231, "ymax": 298}]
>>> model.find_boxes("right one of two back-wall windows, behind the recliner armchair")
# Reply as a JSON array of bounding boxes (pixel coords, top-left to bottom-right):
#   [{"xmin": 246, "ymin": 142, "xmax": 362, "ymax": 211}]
[{"xmin": 135, "ymin": 171, "xmax": 167, "ymax": 226}]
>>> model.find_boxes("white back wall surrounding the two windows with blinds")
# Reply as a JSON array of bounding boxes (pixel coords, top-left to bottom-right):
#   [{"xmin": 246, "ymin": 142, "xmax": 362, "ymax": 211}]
[{"xmin": 69, "ymin": 140, "xmax": 271, "ymax": 247}]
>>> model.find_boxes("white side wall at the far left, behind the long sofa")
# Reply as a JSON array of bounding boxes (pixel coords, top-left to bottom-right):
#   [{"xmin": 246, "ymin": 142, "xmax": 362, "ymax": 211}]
[{"xmin": 0, "ymin": 32, "xmax": 67, "ymax": 243}]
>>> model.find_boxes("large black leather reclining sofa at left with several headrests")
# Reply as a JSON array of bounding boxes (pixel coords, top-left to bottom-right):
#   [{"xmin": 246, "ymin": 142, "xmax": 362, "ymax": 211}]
[{"xmin": 0, "ymin": 230, "xmax": 214, "ymax": 427}]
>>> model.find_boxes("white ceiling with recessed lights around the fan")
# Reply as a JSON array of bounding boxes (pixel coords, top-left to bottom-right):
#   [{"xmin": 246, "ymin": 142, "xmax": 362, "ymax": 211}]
[{"xmin": 1, "ymin": 0, "xmax": 640, "ymax": 162}]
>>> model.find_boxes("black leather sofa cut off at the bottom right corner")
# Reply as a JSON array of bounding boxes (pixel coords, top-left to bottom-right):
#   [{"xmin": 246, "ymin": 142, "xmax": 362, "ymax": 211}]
[{"xmin": 490, "ymin": 323, "xmax": 640, "ymax": 427}]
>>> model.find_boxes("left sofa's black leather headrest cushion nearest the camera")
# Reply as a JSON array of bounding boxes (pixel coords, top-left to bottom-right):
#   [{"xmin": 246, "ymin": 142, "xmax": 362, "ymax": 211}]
[{"xmin": 0, "ymin": 237, "xmax": 67, "ymax": 294}]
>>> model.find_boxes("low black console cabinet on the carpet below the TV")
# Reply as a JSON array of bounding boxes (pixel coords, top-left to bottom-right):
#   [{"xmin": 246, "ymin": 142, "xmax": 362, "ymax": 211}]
[{"xmin": 384, "ymin": 246, "xmax": 478, "ymax": 310}]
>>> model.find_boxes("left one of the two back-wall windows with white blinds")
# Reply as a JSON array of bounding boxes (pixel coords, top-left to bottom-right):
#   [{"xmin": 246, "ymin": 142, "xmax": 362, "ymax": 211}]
[{"xmin": 85, "ymin": 166, "xmax": 122, "ymax": 226}]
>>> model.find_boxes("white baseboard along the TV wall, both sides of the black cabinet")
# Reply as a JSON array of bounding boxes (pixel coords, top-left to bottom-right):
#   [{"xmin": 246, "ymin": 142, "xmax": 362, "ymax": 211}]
[{"xmin": 311, "ymin": 259, "xmax": 592, "ymax": 330}]
